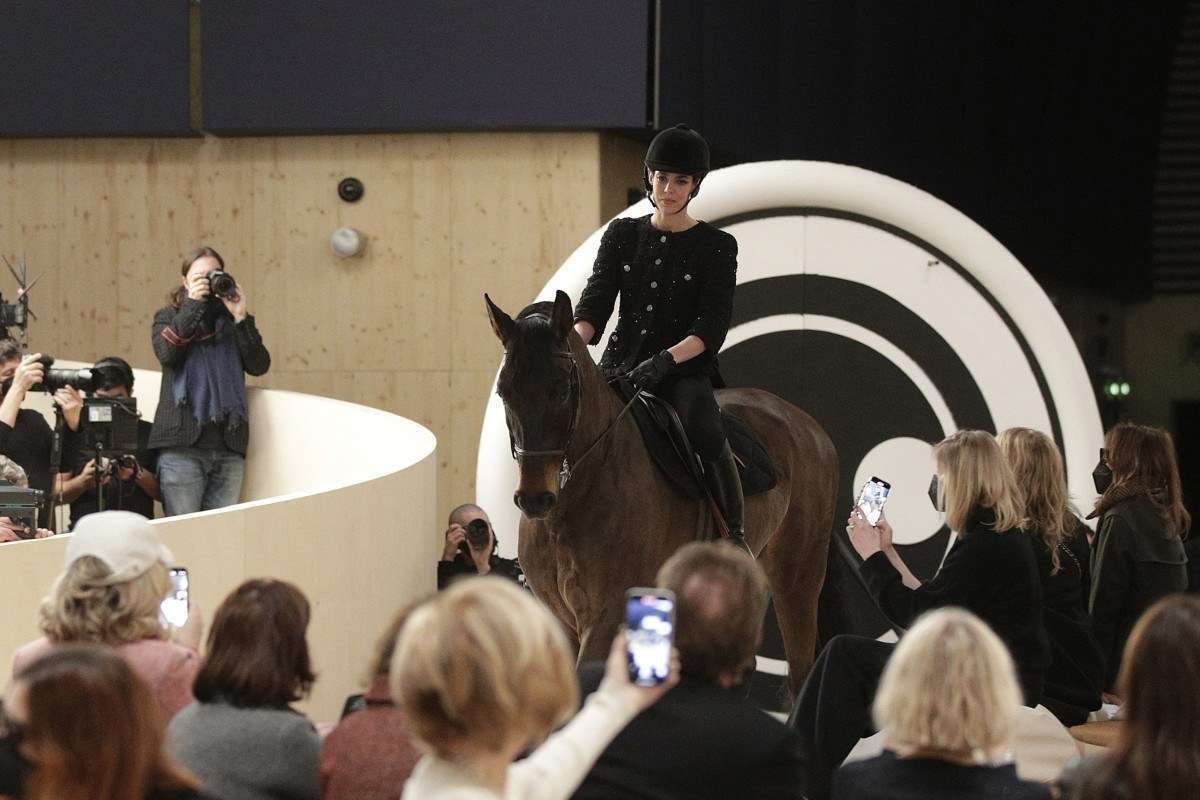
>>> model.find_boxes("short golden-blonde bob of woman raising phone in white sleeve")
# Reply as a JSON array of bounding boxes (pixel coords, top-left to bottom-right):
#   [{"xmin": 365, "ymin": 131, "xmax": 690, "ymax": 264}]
[{"xmin": 390, "ymin": 577, "xmax": 578, "ymax": 758}]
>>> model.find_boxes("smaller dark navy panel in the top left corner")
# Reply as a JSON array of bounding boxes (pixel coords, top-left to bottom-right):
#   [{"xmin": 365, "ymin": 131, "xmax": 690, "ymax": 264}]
[{"xmin": 0, "ymin": 0, "xmax": 188, "ymax": 137}]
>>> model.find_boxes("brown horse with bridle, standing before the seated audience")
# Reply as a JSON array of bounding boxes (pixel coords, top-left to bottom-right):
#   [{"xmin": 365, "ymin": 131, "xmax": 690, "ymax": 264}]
[{"xmin": 485, "ymin": 291, "xmax": 838, "ymax": 692}]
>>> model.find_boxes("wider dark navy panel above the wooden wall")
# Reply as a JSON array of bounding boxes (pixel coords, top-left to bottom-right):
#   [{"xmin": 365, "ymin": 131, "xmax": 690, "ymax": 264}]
[{"xmin": 203, "ymin": 0, "xmax": 650, "ymax": 133}]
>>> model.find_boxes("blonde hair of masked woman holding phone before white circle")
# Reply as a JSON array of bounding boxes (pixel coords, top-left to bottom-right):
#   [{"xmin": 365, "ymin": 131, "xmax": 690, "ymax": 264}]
[{"xmin": 934, "ymin": 431, "xmax": 1025, "ymax": 536}]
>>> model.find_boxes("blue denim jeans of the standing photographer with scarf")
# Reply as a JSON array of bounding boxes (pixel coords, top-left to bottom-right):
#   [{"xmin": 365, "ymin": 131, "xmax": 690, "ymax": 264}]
[{"xmin": 158, "ymin": 447, "xmax": 246, "ymax": 517}]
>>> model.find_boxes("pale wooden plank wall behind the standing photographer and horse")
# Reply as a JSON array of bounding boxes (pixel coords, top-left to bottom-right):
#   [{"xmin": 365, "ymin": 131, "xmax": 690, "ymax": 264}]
[{"xmin": 0, "ymin": 132, "xmax": 640, "ymax": 513}]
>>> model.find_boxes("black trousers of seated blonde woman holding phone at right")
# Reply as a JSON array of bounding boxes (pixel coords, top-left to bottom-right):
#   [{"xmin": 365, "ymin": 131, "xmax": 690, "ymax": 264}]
[{"xmin": 787, "ymin": 636, "xmax": 1043, "ymax": 800}]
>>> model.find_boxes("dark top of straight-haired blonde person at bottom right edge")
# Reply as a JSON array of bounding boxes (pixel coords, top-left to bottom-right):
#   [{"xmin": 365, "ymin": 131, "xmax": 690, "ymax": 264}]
[{"xmin": 833, "ymin": 751, "xmax": 1050, "ymax": 800}]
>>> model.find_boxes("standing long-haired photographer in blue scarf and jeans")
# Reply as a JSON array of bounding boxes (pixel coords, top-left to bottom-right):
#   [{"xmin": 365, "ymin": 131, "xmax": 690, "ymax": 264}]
[{"xmin": 150, "ymin": 247, "xmax": 271, "ymax": 517}]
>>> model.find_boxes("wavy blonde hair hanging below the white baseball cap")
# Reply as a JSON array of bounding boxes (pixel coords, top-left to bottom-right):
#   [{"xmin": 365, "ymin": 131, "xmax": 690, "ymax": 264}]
[{"xmin": 38, "ymin": 555, "xmax": 170, "ymax": 646}]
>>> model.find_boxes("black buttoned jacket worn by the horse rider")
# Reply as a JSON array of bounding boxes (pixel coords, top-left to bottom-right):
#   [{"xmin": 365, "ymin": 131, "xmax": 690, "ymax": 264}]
[{"xmin": 575, "ymin": 216, "xmax": 738, "ymax": 374}]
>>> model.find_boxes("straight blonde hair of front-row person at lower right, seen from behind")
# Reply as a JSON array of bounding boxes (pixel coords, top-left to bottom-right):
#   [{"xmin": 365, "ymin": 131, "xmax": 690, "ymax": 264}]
[{"xmin": 872, "ymin": 607, "xmax": 1021, "ymax": 760}]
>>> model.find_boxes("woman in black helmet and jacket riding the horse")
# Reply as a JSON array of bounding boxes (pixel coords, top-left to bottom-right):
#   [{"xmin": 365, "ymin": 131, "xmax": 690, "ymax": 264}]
[{"xmin": 575, "ymin": 125, "xmax": 750, "ymax": 552}]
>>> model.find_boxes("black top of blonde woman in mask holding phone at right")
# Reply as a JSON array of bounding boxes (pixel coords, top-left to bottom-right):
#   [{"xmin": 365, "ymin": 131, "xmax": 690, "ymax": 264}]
[{"xmin": 862, "ymin": 511, "xmax": 1050, "ymax": 704}]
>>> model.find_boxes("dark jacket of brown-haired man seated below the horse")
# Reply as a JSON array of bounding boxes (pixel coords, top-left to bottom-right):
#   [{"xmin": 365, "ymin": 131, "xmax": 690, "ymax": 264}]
[{"xmin": 574, "ymin": 663, "xmax": 803, "ymax": 800}]
